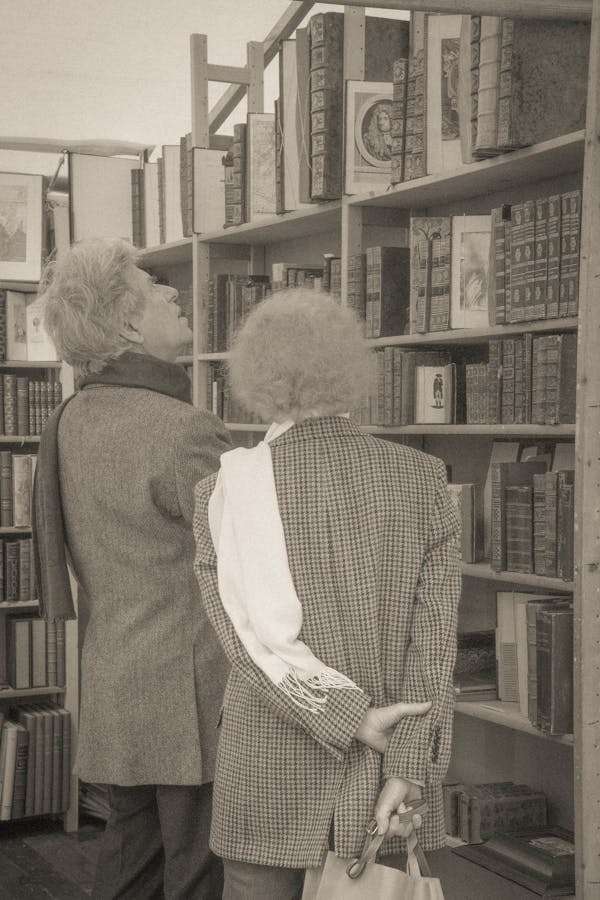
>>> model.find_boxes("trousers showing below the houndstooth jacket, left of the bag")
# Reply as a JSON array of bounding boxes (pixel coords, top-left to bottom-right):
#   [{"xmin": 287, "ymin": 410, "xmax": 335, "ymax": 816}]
[{"xmin": 223, "ymin": 859, "xmax": 304, "ymax": 900}]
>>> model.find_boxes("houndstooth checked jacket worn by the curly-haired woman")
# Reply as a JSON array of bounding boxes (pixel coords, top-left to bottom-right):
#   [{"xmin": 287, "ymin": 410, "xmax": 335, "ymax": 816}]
[{"xmin": 194, "ymin": 416, "xmax": 460, "ymax": 868}]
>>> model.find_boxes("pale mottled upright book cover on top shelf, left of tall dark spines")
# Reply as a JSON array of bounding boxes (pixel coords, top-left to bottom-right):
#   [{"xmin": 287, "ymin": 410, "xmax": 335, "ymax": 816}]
[{"xmin": 246, "ymin": 113, "xmax": 275, "ymax": 222}]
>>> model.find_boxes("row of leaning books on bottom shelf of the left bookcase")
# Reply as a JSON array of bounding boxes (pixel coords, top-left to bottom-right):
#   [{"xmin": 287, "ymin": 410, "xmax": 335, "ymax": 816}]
[{"xmin": 0, "ymin": 704, "xmax": 71, "ymax": 822}]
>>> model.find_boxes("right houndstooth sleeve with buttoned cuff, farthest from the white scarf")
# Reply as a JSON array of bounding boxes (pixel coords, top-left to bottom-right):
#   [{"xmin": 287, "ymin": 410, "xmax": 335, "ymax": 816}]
[{"xmin": 383, "ymin": 461, "xmax": 461, "ymax": 783}]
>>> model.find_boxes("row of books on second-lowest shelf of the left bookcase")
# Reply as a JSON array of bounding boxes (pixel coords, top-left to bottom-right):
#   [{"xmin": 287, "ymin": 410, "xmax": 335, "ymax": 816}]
[{"xmin": 0, "ymin": 616, "xmax": 66, "ymax": 698}]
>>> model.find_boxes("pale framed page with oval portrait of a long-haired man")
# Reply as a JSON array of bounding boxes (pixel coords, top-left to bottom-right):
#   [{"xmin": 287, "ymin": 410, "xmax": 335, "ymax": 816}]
[{"xmin": 346, "ymin": 81, "xmax": 393, "ymax": 194}]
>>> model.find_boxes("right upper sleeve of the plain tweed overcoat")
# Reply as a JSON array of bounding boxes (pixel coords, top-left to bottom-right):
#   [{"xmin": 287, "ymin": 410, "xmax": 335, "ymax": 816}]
[{"xmin": 175, "ymin": 410, "xmax": 231, "ymax": 525}]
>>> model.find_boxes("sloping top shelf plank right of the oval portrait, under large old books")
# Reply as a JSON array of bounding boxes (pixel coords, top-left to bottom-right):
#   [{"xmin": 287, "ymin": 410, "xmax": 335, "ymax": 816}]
[{"xmin": 348, "ymin": 131, "xmax": 584, "ymax": 210}]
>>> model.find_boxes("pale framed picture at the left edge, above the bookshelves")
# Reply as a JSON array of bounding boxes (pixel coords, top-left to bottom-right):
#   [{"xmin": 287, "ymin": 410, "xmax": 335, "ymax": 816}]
[{"xmin": 0, "ymin": 172, "xmax": 43, "ymax": 281}]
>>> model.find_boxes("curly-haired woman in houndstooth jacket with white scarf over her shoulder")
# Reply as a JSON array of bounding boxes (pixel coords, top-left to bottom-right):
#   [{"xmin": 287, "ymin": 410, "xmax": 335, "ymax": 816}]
[{"xmin": 194, "ymin": 289, "xmax": 460, "ymax": 900}]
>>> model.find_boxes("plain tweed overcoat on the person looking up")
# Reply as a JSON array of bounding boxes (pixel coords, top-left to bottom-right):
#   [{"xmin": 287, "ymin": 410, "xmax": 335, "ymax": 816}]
[{"xmin": 58, "ymin": 385, "xmax": 230, "ymax": 785}]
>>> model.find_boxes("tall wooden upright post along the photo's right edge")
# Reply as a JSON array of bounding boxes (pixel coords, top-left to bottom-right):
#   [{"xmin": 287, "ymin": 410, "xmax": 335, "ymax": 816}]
[{"xmin": 574, "ymin": 0, "xmax": 600, "ymax": 898}]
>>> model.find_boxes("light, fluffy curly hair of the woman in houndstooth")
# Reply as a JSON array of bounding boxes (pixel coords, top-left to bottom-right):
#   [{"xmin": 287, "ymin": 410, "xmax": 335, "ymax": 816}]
[{"xmin": 229, "ymin": 288, "xmax": 374, "ymax": 422}]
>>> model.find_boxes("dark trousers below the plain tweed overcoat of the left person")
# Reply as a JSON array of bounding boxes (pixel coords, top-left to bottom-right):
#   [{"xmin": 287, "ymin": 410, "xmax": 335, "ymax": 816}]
[{"xmin": 92, "ymin": 784, "xmax": 223, "ymax": 900}]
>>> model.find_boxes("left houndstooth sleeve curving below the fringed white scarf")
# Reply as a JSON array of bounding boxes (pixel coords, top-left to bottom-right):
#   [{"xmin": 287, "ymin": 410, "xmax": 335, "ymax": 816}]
[{"xmin": 194, "ymin": 477, "xmax": 371, "ymax": 760}]
